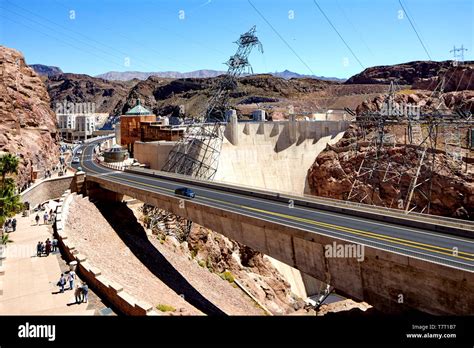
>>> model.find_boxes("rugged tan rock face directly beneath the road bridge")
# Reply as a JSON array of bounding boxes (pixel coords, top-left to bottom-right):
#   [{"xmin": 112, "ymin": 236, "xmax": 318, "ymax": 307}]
[{"xmin": 141, "ymin": 206, "xmax": 304, "ymax": 314}]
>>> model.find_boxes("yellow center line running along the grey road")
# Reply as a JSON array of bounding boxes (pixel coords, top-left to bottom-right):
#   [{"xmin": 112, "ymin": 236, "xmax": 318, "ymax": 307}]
[{"xmin": 81, "ymin": 143, "xmax": 474, "ymax": 261}]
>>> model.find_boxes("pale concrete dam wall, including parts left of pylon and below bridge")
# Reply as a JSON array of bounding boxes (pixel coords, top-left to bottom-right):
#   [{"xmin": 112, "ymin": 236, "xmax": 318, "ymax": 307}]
[{"xmin": 131, "ymin": 118, "xmax": 350, "ymax": 298}]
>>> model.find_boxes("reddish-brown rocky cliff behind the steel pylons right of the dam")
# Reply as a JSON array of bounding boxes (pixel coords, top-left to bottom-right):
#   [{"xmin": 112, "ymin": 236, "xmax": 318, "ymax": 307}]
[{"xmin": 308, "ymin": 91, "xmax": 474, "ymax": 219}]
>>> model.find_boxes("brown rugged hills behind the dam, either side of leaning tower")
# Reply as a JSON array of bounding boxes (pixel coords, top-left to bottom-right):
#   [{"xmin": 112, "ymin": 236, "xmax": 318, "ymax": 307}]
[{"xmin": 46, "ymin": 74, "xmax": 337, "ymax": 123}]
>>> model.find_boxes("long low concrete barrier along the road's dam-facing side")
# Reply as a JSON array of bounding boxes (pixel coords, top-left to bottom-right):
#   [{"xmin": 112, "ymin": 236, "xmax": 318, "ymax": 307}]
[{"xmin": 117, "ymin": 167, "xmax": 474, "ymax": 238}]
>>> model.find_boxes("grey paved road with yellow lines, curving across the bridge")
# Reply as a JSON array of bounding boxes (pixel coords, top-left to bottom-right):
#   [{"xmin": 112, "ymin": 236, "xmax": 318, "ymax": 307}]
[{"xmin": 72, "ymin": 139, "xmax": 474, "ymax": 272}]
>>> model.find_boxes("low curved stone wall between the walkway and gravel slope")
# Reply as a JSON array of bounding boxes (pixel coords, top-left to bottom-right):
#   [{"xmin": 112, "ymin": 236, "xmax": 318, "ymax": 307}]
[{"xmin": 54, "ymin": 191, "xmax": 159, "ymax": 315}]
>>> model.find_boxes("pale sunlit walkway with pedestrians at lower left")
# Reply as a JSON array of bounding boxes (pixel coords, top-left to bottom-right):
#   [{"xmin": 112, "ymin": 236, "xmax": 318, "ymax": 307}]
[{"xmin": 0, "ymin": 212, "xmax": 95, "ymax": 315}]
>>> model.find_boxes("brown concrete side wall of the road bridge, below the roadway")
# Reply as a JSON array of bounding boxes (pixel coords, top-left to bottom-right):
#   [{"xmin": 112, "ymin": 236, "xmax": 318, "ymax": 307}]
[{"xmin": 87, "ymin": 177, "xmax": 474, "ymax": 315}]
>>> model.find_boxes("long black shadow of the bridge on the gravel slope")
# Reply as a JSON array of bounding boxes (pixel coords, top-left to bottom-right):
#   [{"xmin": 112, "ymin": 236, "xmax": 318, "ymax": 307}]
[{"xmin": 94, "ymin": 201, "xmax": 226, "ymax": 315}]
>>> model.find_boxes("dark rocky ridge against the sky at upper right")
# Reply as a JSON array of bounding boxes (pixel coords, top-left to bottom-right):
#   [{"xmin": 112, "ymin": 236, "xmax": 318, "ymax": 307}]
[{"xmin": 345, "ymin": 61, "xmax": 466, "ymax": 85}]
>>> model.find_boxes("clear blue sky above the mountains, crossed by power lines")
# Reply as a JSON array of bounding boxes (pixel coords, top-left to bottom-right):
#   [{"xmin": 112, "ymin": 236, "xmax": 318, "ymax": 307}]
[{"xmin": 0, "ymin": 0, "xmax": 474, "ymax": 77}]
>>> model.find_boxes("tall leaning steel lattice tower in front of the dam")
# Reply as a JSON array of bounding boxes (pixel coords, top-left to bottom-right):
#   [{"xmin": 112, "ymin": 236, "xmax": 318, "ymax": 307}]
[{"xmin": 162, "ymin": 26, "xmax": 263, "ymax": 180}]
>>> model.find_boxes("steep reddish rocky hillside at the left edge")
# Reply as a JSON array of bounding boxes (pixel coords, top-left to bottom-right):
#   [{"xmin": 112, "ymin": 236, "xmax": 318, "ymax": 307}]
[{"xmin": 0, "ymin": 46, "xmax": 59, "ymax": 187}]
